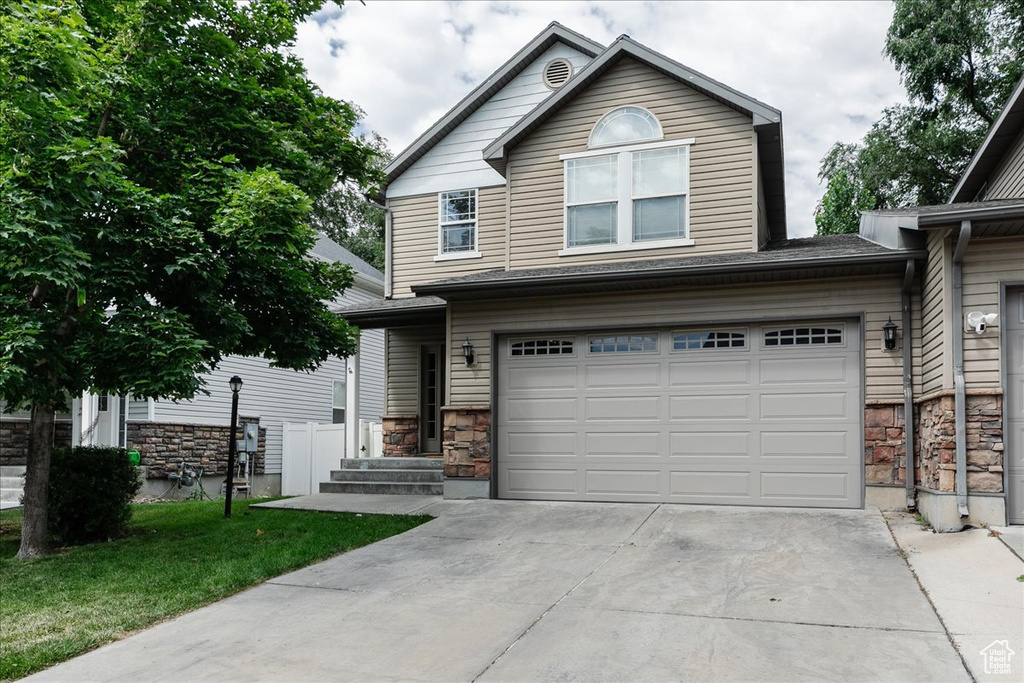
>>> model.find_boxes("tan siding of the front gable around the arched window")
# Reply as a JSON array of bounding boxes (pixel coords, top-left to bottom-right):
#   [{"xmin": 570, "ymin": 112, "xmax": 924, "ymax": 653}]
[{"xmin": 509, "ymin": 59, "xmax": 756, "ymax": 268}]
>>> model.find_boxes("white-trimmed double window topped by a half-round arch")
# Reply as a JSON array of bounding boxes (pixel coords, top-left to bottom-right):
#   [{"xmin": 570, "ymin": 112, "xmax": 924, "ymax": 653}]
[{"xmin": 560, "ymin": 106, "xmax": 693, "ymax": 255}]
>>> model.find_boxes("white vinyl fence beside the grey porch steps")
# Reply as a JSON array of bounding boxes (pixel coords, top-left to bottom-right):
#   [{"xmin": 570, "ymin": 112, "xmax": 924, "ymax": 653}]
[{"xmin": 281, "ymin": 422, "xmax": 345, "ymax": 496}]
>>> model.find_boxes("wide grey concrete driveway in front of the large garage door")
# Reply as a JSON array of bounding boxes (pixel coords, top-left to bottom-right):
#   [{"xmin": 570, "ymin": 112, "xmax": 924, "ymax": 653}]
[{"xmin": 25, "ymin": 501, "xmax": 970, "ymax": 682}]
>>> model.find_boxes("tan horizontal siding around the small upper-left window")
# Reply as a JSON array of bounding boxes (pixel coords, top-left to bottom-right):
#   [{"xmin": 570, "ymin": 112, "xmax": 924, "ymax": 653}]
[{"xmin": 389, "ymin": 187, "xmax": 505, "ymax": 298}]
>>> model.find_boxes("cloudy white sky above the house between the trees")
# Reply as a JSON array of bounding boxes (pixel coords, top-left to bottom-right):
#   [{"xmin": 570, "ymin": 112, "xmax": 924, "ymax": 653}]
[{"xmin": 295, "ymin": 0, "xmax": 904, "ymax": 237}]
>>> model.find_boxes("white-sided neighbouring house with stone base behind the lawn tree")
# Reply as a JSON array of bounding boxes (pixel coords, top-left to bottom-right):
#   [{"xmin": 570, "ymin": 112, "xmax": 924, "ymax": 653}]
[{"xmin": 0, "ymin": 236, "xmax": 384, "ymax": 493}]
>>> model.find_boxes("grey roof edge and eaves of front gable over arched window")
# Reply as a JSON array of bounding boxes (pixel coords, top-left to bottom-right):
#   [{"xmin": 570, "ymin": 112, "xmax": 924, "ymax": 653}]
[{"xmin": 483, "ymin": 36, "xmax": 785, "ymax": 240}]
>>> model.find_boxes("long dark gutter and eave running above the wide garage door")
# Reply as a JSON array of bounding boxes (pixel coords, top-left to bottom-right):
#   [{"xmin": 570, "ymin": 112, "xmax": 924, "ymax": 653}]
[{"xmin": 413, "ymin": 250, "xmax": 928, "ymax": 300}]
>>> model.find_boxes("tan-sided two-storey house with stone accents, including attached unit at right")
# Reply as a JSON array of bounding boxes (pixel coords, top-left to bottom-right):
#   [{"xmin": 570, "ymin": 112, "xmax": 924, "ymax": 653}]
[{"xmin": 343, "ymin": 24, "xmax": 1024, "ymax": 527}]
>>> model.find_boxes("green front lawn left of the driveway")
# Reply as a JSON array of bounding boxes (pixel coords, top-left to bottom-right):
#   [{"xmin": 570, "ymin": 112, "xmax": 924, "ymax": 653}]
[{"xmin": 0, "ymin": 501, "xmax": 430, "ymax": 681}]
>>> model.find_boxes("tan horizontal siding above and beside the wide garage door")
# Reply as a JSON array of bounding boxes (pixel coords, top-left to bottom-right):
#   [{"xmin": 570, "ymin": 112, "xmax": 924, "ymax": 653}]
[{"xmin": 449, "ymin": 276, "xmax": 921, "ymax": 405}]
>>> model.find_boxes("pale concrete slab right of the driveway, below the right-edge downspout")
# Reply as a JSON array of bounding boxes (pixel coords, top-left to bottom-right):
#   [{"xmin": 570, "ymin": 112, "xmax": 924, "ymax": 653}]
[{"xmin": 886, "ymin": 513, "xmax": 1024, "ymax": 681}]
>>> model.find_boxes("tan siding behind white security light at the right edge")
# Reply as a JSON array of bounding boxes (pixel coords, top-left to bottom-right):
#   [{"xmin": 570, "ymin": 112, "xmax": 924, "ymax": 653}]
[{"xmin": 954, "ymin": 238, "xmax": 1024, "ymax": 388}]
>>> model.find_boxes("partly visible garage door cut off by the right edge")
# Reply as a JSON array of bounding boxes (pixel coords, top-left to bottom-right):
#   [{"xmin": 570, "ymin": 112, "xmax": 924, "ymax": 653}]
[{"xmin": 1005, "ymin": 290, "xmax": 1024, "ymax": 524}]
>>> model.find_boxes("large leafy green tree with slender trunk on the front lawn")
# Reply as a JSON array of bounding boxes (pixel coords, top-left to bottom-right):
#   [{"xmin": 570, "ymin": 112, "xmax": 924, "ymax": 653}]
[{"xmin": 0, "ymin": 0, "xmax": 376, "ymax": 558}]
